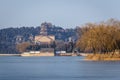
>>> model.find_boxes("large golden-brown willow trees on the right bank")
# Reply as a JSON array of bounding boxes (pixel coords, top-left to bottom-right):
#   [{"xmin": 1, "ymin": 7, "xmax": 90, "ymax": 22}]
[{"xmin": 77, "ymin": 19, "xmax": 120, "ymax": 53}]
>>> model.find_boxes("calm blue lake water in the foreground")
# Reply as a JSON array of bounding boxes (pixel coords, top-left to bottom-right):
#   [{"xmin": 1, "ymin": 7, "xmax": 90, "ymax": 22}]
[{"xmin": 0, "ymin": 56, "xmax": 120, "ymax": 80}]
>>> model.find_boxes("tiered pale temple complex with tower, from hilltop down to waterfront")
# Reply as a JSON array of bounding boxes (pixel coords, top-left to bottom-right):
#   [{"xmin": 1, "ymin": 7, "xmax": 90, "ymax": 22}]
[{"xmin": 21, "ymin": 22, "xmax": 55, "ymax": 56}]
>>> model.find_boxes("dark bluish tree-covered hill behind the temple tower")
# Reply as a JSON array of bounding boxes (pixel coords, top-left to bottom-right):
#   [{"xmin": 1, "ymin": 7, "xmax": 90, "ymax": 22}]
[{"xmin": 0, "ymin": 22, "xmax": 76, "ymax": 53}]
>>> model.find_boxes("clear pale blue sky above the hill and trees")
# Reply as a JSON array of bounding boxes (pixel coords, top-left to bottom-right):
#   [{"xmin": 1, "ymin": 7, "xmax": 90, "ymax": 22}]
[{"xmin": 0, "ymin": 0, "xmax": 120, "ymax": 29}]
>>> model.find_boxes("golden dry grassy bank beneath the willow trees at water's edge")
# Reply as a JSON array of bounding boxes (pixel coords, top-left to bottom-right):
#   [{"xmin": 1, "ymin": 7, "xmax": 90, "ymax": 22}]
[{"xmin": 85, "ymin": 53, "xmax": 120, "ymax": 61}]
